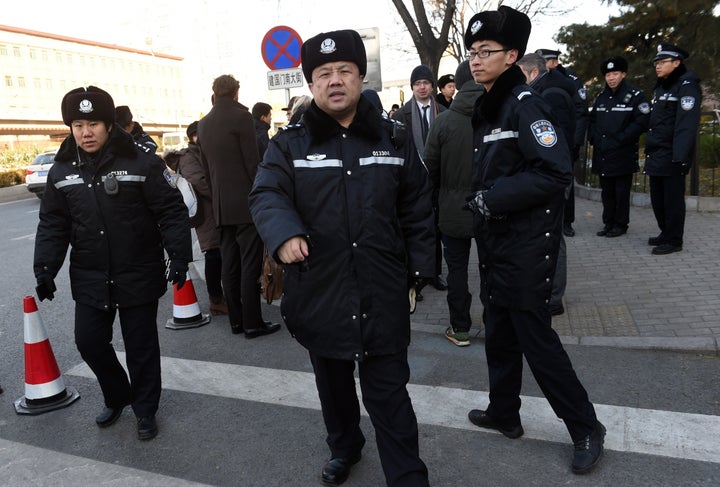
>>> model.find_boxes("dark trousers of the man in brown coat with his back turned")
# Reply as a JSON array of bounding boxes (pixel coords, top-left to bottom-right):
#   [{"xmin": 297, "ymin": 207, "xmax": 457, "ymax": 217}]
[{"xmin": 220, "ymin": 223, "xmax": 263, "ymax": 329}]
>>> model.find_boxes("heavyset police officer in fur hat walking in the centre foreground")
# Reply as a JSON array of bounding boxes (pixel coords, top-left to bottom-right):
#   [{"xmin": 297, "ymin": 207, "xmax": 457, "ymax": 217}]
[{"xmin": 250, "ymin": 30, "xmax": 435, "ymax": 486}]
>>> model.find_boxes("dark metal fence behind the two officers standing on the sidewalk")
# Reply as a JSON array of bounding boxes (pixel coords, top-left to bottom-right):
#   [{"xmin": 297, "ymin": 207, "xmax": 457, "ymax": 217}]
[{"xmin": 575, "ymin": 110, "xmax": 720, "ymax": 196}]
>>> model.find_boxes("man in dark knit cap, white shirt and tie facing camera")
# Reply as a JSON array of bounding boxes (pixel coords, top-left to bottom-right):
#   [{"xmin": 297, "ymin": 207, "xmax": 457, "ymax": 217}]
[{"xmin": 392, "ymin": 64, "xmax": 447, "ymax": 301}]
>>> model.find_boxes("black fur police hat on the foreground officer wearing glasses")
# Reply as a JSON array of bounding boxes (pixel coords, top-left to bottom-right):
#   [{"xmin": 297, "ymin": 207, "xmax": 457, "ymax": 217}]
[{"xmin": 465, "ymin": 5, "xmax": 531, "ymax": 59}]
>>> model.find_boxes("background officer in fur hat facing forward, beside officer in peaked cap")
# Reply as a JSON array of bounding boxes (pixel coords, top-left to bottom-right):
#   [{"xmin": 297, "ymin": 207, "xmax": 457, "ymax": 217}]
[{"xmin": 588, "ymin": 56, "xmax": 650, "ymax": 238}]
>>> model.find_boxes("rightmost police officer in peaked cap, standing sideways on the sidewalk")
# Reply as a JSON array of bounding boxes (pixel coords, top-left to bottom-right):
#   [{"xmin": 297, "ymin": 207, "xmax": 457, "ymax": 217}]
[{"xmin": 643, "ymin": 43, "xmax": 702, "ymax": 255}]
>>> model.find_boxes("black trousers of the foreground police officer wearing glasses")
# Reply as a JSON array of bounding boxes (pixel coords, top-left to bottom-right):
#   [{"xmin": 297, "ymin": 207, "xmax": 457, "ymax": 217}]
[{"xmin": 484, "ymin": 303, "xmax": 597, "ymax": 441}]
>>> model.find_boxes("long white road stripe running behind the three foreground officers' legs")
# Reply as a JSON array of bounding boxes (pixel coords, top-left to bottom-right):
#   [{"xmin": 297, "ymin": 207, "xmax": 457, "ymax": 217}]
[{"xmin": 67, "ymin": 353, "xmax": 720, "ymax": 463}]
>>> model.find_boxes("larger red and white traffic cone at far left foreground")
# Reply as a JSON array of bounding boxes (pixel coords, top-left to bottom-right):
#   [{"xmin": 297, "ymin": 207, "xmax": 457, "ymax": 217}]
[{"xmin": 15, "ymin": 296, "xmax": 80, "ymax": 414}]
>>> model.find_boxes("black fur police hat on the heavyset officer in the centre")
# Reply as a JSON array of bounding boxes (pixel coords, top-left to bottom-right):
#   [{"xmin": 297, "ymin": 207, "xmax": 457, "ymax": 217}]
[{"xmin": 300, "ymin": 30, "xmax": 367, "ymax": 83}]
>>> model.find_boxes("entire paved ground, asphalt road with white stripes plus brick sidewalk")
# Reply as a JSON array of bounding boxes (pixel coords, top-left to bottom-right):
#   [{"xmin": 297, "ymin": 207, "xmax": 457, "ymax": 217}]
[{"xmin": 0, "ymin": 185, "xmax": 720, "ymax": 487}]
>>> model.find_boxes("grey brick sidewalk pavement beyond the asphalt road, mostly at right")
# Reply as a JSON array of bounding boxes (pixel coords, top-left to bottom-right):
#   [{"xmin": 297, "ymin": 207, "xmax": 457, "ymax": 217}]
[{"xmin": 0, "ymin": 185, "xmax": 720, "ymax": 354}]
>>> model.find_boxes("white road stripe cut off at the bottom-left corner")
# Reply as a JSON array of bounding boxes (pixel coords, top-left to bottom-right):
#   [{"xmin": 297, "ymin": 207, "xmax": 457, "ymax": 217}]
[{"xmin": 0, "ymin": 439, "xmax": 211, "ymax": 487}]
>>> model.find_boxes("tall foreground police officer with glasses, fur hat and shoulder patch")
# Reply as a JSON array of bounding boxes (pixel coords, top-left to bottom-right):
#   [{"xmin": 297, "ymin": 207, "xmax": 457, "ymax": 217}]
[{"xmin": 465, "ymin": 6, "xmax": 605, "ymax": 474}]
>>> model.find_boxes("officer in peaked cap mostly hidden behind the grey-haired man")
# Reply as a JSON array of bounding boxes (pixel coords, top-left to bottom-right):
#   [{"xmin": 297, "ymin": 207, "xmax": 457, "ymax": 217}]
[{"xmin": 535, "ymin": 49, "xmax": 588, "ymax": 237}]
